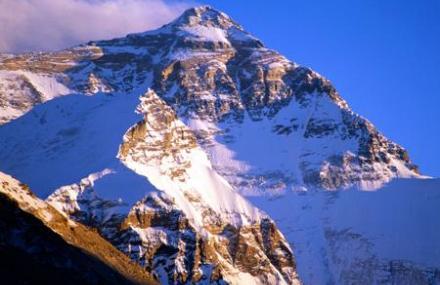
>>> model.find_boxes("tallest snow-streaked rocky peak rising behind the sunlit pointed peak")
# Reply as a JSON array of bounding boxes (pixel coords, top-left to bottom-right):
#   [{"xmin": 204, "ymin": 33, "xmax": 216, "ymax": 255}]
[{"xmin": 0, "ymin": 7, "xmax": 419, "ymax": 192}]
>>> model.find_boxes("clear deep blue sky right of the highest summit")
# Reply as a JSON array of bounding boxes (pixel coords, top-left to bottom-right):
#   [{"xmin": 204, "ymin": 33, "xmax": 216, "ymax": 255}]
[{"xmin": 198, "ymin": 0, "xmax": 440, "ymax": 177}]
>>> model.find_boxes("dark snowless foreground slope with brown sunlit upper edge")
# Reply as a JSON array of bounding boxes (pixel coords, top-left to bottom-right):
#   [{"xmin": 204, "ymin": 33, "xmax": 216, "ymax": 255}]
[{"xmin": 0, "ymin": 170, "xmax": 156, "ymax": 284}]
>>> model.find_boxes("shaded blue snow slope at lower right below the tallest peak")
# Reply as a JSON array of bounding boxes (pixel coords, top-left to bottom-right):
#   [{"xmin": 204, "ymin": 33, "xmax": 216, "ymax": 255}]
[{"xmin": 250, "ymin": 179, "xmax": 440, "ymax": 284}]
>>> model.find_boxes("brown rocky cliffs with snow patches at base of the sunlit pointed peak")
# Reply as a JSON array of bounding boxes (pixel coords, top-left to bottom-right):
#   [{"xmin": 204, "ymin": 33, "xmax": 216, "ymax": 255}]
[{"xmin": 48, "ymin": 172, "xmax": 299, "ymax": 284}]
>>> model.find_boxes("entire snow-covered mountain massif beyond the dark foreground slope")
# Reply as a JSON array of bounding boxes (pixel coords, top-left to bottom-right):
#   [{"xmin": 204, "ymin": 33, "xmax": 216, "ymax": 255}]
[{"xmin": 0, "ymin": 6, "xmax": 434, "ymax": 284}]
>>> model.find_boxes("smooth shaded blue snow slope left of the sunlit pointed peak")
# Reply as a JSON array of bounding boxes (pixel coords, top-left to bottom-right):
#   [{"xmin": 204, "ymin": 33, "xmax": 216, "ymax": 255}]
[{"xmin": 0, "ymin": 93, "xmax": 141, "ymax": 197}]
